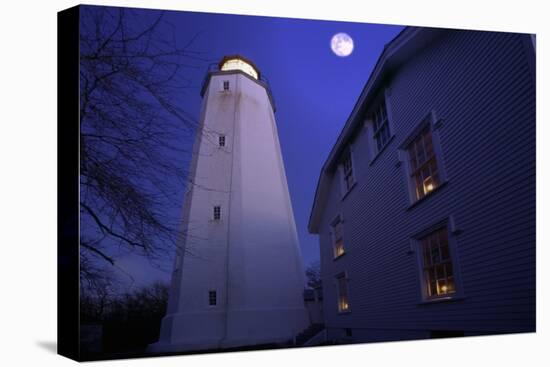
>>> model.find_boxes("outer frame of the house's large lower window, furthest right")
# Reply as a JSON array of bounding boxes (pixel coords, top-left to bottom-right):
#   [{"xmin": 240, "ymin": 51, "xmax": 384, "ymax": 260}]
[{"xmin": 411, "ymin": 220, "xmax": 464, "ymax": 304}]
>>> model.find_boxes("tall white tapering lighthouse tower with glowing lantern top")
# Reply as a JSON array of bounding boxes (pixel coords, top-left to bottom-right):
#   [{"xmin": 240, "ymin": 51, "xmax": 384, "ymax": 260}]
[{"xmin": 150, "ymin": 56, "xmax": 309, "ymax": 351}]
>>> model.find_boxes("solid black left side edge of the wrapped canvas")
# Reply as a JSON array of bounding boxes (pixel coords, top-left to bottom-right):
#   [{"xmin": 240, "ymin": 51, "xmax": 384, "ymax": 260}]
[{"xmin": 57, "ymin": 6, "xmax": 80, "ymax": 360}]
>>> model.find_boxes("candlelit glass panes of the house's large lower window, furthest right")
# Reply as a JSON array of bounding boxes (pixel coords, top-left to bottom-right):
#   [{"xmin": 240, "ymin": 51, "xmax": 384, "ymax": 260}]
[{"xmin": 419, "ymin": 227, "xmax": 456, "ymax": 298}]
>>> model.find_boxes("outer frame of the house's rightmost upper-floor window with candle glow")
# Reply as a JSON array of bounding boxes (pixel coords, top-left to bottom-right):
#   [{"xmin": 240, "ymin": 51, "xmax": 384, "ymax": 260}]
[{"xmin": 398, "ymin": 110, "xmax": 448, "ymax": 207}]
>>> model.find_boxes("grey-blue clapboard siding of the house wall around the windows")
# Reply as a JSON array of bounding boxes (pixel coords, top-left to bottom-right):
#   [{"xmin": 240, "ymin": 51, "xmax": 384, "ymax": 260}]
[{"xmin": 319, "ymin": 30, "xmax": 536, "ymax": 341}]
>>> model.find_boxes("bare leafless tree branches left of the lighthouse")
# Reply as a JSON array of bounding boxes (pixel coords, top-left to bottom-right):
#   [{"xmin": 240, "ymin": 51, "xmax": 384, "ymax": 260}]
[{"xmin": 80, "ymin": 7, "xmax": 204, "ymax": 294}]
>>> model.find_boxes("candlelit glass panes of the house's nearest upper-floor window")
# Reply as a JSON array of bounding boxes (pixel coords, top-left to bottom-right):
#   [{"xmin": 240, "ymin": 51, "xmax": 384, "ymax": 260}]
[{"xmin": 407, "ymin": 124, "xmax": 441, "ymax": 200}]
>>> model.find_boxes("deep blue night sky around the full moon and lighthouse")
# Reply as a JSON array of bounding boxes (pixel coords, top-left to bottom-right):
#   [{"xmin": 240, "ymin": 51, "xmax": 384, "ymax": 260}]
[{"xmin": 104, "ymin": 5, "xmax": 403, "ymax": 285}]
